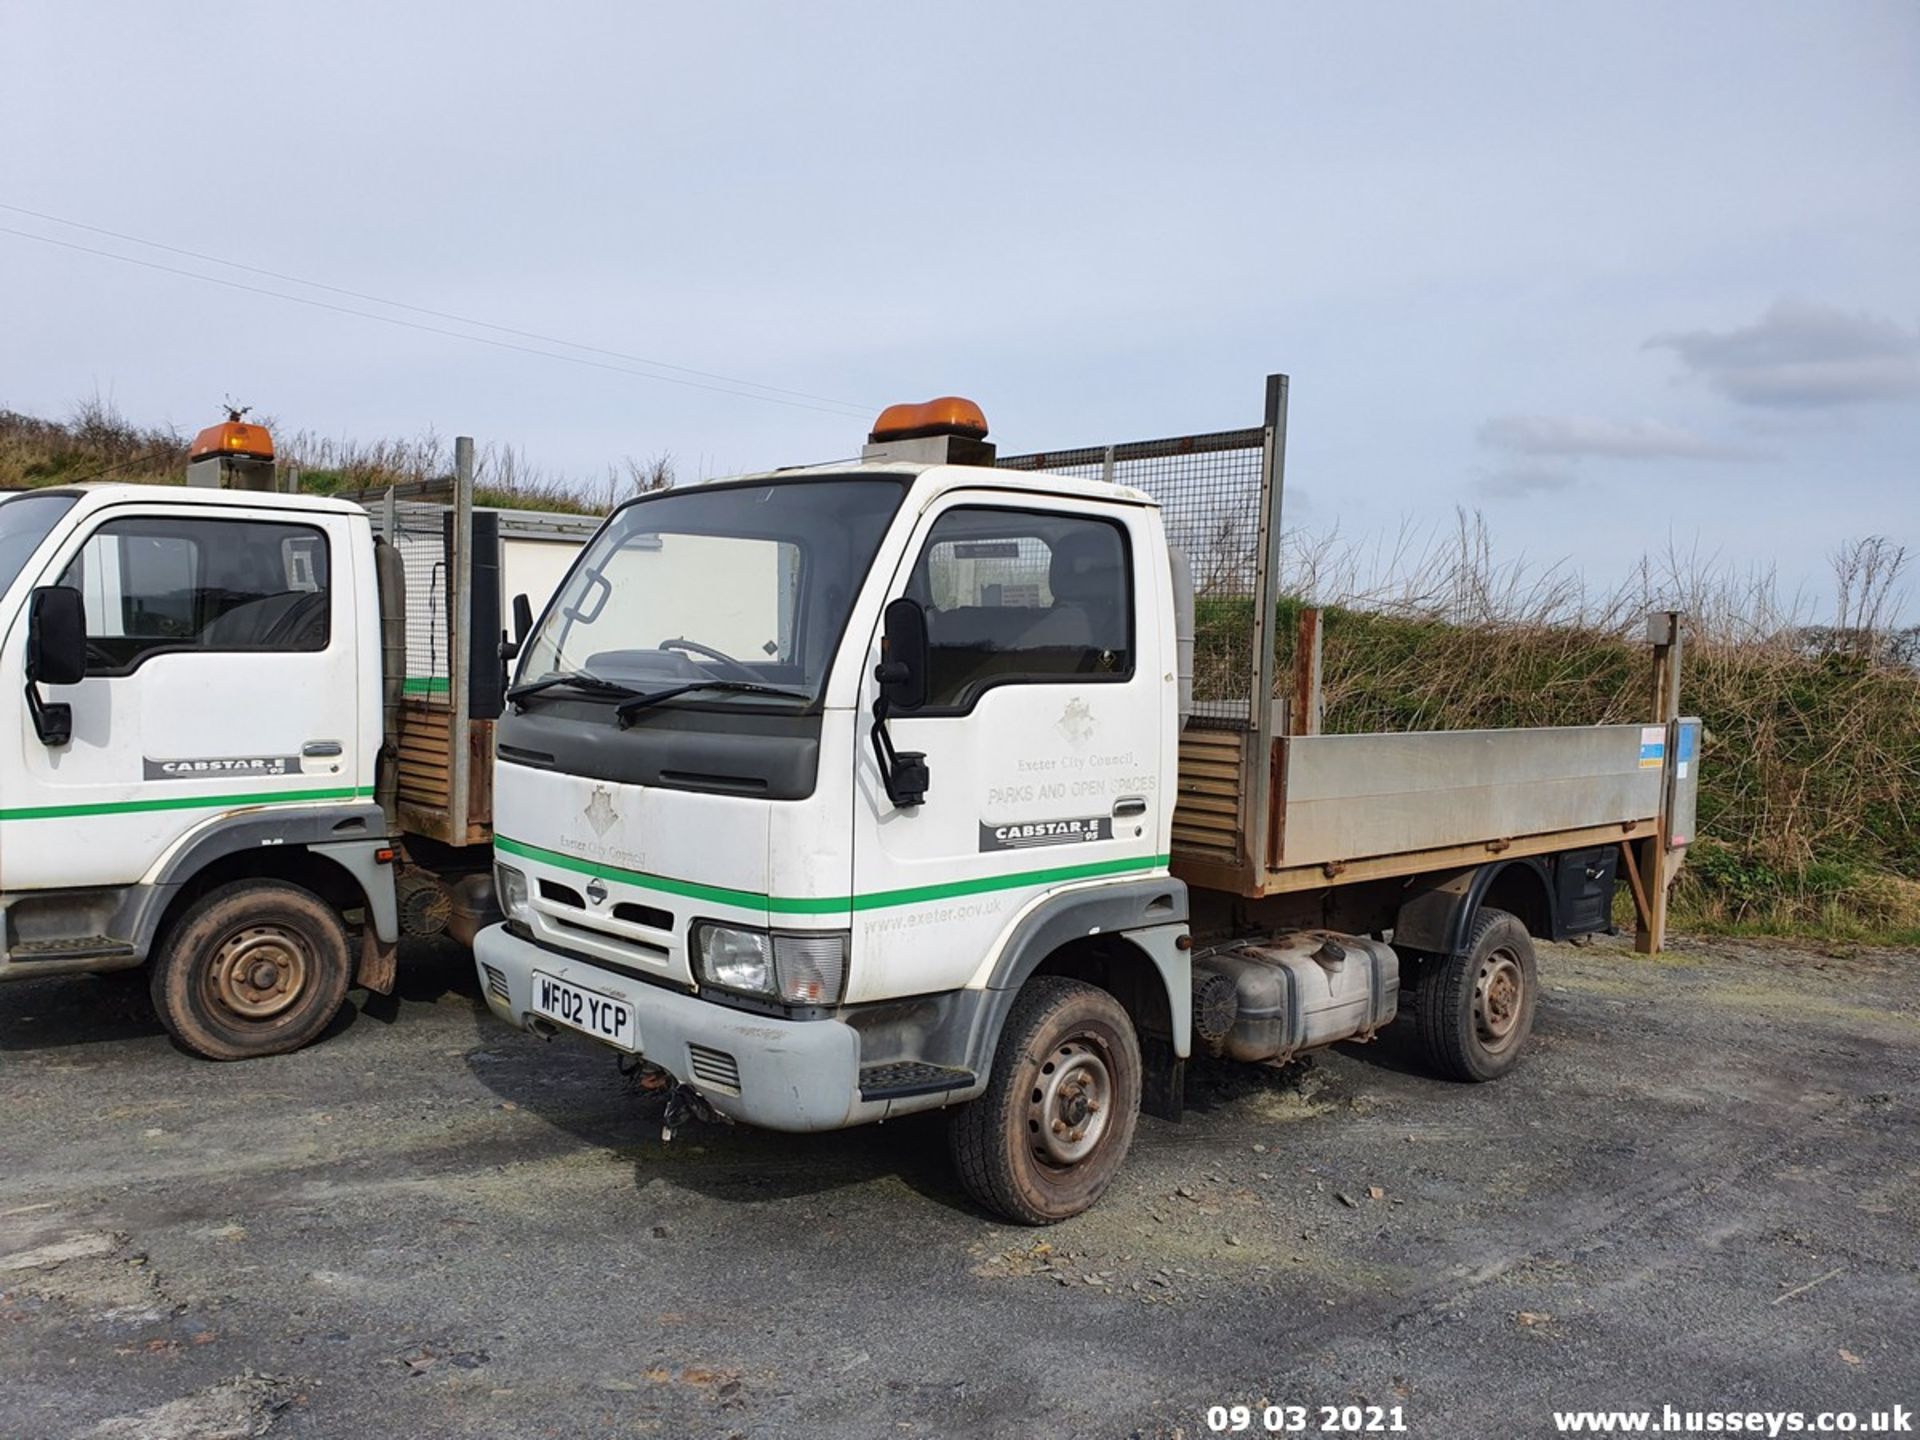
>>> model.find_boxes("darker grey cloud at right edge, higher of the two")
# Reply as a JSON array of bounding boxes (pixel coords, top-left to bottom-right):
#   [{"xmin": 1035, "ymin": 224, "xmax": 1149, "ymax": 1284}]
[{"xmin": 1647, "ymin": 300, "xmax": 1920, "ymax": 409}]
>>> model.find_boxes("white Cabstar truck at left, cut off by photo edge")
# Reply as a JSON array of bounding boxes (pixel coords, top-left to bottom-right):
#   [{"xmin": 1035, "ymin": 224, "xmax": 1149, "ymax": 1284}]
[{"xmin": 0, "ymin": 415, "xmax": 597, "ymax": 1060}]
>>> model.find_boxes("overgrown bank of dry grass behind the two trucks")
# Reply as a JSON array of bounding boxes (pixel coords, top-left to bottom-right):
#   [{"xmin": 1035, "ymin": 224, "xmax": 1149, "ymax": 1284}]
[{"xmin": 0, "ymin": 401, "xmax": 1920, "ymax": 945}]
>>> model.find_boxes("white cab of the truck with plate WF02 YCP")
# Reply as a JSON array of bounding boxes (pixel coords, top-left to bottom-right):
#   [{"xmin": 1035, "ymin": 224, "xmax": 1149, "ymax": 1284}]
[{"xmin": 476, "ymin": 401, "xmax": 1187, "ymax": 1221}]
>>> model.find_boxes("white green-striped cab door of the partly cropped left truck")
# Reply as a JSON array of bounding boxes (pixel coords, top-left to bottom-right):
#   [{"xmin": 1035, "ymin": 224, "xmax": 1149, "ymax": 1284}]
[{"xmin": 0, "ymin": 505, "xmax": 371, "ymax": 891}]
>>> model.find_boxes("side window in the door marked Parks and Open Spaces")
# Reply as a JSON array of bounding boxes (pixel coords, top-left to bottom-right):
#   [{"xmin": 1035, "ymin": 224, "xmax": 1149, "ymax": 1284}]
[{"xmin": 908, "ymin": 507, "xmax": 1133, "ymax": 710}]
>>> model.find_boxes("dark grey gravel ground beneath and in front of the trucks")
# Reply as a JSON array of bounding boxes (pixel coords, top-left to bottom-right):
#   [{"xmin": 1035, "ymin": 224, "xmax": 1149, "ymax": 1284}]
[{"xmin": 0, "ymin": 943, "xmax": 1920, "ymax": 1440}]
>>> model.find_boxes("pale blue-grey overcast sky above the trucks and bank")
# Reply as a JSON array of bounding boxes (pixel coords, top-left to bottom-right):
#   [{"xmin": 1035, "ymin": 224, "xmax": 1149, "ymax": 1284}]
[{"xmin": 0, "ymin": 0, "xmax": 1920, "ymax": 612}]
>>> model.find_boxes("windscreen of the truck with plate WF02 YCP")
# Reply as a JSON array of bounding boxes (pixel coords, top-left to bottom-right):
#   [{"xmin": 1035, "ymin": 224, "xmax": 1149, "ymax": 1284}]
[{"xmin": 518, "ymin": 478, "xmax": 906, "ymax": 705}]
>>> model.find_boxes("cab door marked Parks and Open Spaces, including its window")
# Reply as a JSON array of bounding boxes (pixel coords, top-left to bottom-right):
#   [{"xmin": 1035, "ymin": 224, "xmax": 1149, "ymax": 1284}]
[{"xmin": 849, "ymin": 490, "xmax": 1177, "ymax": 1000}]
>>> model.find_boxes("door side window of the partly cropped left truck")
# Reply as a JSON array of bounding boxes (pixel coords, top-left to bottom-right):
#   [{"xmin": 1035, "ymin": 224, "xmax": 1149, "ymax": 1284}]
[{"xmin": 60, "ymin": 516, "xmax": 330, "ymax": 676}]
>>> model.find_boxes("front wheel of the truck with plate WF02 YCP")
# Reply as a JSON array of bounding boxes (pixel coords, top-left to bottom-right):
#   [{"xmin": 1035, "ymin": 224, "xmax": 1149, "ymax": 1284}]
[{"xmin": 948, "ymin": 975, "xmax": 1140, "ymax": 1225}]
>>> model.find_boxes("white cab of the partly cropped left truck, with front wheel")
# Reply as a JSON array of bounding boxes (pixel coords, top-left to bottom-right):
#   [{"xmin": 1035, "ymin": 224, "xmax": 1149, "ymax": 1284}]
[{"xmin": 0, "ymin": 484, "xmax": 396, "ymax": 1054}]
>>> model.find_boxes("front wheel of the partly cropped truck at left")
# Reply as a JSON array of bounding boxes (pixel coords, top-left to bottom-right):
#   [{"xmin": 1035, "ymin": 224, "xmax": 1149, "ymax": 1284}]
[{"xmin": 152, "ymin": 879, "xmax": 351, "ymax": 1060}]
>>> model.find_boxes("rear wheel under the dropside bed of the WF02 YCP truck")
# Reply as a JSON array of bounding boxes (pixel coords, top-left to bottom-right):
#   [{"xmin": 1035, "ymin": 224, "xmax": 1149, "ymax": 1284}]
[{"xmin": 1415, "ymin": 910, "xmax": 1540, "ymax": 1081}]
